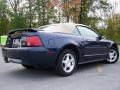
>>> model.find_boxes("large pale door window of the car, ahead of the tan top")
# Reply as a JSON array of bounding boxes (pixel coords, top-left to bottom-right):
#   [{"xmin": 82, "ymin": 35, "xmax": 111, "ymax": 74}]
[{"xmin": 77, "ymin": 26, "xmax": 98, "ymax": 38}]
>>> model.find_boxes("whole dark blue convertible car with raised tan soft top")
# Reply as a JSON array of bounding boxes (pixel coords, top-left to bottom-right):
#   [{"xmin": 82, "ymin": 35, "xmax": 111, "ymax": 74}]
[{"xmin": 2, "ymin": 23, "xmax": 119, "ymax": 76}]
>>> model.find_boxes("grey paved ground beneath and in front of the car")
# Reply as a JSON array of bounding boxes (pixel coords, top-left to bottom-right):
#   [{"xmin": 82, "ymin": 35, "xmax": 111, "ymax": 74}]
[{"xmin": 0, "ymin": 47, "xmax": 120, "ymax": 90}]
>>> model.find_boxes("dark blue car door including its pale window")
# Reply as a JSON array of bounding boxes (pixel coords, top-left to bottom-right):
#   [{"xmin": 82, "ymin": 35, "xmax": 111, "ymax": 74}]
[{"xmin": 77, "ymin": 26, "xmax": 108, "ymax": 61}]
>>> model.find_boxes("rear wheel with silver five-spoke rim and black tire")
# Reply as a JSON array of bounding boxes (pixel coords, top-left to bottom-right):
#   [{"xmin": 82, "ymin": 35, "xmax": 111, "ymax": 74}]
[{"xmin": 55, "ymin": 49, "xmax": 77, "ymax": 76}]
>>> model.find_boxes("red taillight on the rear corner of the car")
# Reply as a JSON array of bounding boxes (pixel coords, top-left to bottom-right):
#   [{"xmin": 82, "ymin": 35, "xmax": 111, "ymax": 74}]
[{"xmin": 26, "ymin": 36, "xmax": 43, "ymax": 47}]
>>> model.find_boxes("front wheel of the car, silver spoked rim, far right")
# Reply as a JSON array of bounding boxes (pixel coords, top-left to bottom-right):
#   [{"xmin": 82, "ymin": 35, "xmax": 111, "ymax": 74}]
[{"xmin": 106, "ymin": 48, "xmax": 119, "ymax": 64}]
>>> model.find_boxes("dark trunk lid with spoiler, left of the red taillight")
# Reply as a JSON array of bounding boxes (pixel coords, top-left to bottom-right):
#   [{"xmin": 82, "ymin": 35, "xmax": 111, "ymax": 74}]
[{"xmin": 6, "ymin": 29, "xmax": 37, "ymax": 48}]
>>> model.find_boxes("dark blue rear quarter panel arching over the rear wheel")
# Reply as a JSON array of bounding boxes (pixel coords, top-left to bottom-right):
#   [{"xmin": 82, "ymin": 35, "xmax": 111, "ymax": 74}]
[{"xmin": 37, "ymin": 32, "xmax": 83, "ymax": 59}]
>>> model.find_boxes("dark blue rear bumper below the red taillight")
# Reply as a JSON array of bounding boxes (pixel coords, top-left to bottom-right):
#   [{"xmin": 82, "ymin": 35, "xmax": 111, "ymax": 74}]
[{"xmin": 2, "ymin": 47, "xmax": 57, "ymax": 67}]
